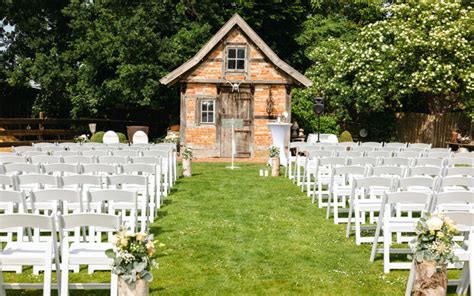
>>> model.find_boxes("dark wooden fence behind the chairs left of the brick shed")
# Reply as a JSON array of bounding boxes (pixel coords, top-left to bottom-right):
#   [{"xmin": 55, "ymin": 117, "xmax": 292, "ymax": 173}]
[{"xmin": 0, "ymin": 118, "xmax": 157, "ymax": 147}]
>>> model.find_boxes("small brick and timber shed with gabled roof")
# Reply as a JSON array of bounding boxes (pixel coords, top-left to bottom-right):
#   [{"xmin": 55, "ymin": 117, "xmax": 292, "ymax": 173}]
[{"xmin": 160, "ymin": 14, "xmax": 312, "ymax": 158}]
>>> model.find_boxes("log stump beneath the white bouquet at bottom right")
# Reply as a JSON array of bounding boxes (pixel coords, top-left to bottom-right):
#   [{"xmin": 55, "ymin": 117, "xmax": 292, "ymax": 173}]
[{"xmin": 412, "ymin": 261, "xmax": 448, "ymax": 296}]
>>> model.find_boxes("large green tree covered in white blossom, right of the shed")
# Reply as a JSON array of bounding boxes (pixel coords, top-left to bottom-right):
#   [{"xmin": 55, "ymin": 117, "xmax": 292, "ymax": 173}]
[{"xmin": 307, "ymin": 1, "xmax": 474, "ymax": 126}]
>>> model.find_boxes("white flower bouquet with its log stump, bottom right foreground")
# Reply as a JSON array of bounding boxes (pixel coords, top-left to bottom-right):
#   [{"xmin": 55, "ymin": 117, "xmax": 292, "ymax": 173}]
[{"xmin": 409, "ymin": 215, "xmax": 458, "ymax": 295}]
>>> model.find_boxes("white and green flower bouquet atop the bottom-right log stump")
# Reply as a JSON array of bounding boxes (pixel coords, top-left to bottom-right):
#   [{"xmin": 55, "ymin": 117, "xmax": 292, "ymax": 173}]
[{"xmin": 409, "ymin": 215, "xmax": 459, "ymax": 266}]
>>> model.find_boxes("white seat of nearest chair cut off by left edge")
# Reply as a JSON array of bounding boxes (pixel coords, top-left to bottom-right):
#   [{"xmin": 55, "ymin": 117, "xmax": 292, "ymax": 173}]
[{"xmin": 0, "ymin": 242, "xmax": 54, "ymax": 265}]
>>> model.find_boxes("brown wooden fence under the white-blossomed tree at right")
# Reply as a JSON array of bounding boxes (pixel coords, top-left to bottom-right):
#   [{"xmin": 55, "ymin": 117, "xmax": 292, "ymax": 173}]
[{"xmin": 396, "ymin": 112, "xmax": 473, "ymax": 147}]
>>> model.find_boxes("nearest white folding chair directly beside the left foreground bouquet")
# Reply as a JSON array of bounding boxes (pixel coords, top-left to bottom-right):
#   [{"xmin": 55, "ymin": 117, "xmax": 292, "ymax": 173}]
[{"xmin": 58, "ymin": 213, "xmax": 121, "ymax": 296}]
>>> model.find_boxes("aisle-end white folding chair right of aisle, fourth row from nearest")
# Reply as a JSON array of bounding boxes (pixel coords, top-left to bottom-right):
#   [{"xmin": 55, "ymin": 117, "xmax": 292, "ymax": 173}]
[{"xmin": 326, "ymin": 166, "xmax": 368, "ymax": 224}]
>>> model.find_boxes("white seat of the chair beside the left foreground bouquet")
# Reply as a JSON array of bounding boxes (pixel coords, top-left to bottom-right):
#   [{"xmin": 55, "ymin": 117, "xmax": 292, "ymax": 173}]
[{"xmin": 69, "ymin": 243, "xmax": 113, "ymax": 264}]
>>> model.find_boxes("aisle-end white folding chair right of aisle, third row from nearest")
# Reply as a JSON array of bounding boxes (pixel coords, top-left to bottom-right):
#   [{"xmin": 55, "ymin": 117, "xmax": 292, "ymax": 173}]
[{"xmin": 346, "ymin": 177, "xmax": 396, "ymax": 245}]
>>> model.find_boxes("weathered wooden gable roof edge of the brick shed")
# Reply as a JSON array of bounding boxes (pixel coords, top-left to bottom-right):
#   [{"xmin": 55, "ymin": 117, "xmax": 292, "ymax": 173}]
[{"xmin": 160, "ymin": 13, "xmax": 313, "ymax": 87}]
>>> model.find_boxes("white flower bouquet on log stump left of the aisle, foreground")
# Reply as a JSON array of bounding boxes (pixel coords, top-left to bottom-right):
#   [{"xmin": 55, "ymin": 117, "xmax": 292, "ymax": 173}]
[{"xmin": 106, "ymin": 228, "xmax": 157, "ymax": 296}]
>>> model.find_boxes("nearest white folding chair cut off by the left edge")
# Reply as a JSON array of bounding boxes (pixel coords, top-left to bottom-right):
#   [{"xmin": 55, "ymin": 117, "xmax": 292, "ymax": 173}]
[{"xmin": 0, "ymin": 214, "xmax": 62, "ymax": 296}]
